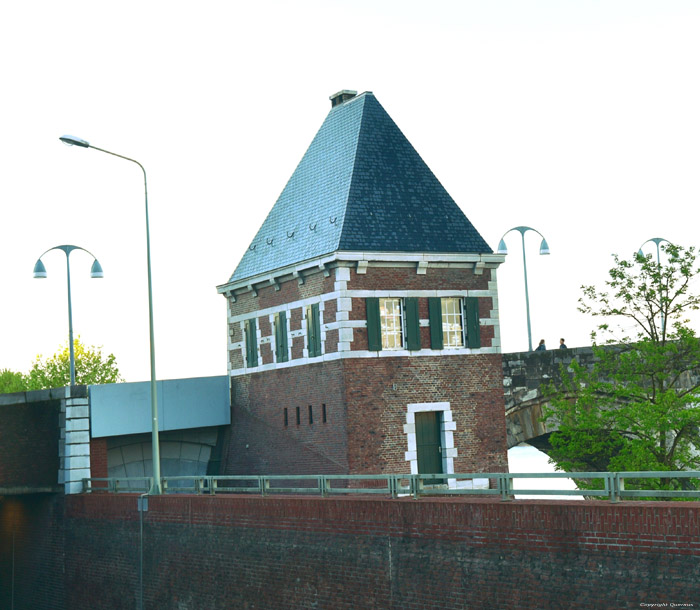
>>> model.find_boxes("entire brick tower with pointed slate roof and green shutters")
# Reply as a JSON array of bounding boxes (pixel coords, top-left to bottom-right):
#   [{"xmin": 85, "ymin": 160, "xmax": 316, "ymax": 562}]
[{"xmin": 218, "ymin": 91, "xmax": 507, "ymax": 474}]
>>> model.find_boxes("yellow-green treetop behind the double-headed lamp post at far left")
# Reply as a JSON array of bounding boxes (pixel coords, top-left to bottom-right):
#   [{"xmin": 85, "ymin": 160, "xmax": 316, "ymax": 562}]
[{"xmin": 25, "ymin": 337, "xmax": 123, "ymax": 390}]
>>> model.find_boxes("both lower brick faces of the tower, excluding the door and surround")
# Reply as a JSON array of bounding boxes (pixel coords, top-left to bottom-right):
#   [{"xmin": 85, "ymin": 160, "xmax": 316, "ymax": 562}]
[{"xmin": 227, "ymin": 354, "xmax": 508, "ymax": 474}]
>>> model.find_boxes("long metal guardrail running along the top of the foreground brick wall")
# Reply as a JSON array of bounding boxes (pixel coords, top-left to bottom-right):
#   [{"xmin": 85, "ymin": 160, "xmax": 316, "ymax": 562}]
[{"xmin": 83, "ymin": 471, "xmax": 700, "ymax": 502}]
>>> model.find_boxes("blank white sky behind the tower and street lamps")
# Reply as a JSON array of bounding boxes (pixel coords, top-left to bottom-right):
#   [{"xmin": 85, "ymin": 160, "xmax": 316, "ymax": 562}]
[{"xmin": 0, "ymin": 0, "xmax": 700, "ymax": 381}]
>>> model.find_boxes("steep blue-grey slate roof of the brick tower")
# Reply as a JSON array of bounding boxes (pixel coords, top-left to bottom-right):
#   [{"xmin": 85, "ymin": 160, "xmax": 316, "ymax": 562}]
[{"xmin": 229, "ymin": 92, "xmax": 493, "ymax": 282}]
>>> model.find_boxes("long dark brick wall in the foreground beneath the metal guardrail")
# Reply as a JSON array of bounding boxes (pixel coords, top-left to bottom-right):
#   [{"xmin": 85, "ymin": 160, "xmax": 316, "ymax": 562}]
[{"xmin": 53, "ymin": 495, "xmax": 700, "ymax": 610}]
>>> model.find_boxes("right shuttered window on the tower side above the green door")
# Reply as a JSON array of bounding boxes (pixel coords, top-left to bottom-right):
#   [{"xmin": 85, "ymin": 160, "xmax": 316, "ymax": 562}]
[{"xmin": 428, "ymin": 297, "xmax": 481, "ymax": 349}]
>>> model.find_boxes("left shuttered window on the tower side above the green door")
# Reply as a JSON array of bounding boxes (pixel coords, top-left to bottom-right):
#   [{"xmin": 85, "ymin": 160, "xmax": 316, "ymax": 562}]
[{"xmin": 365, "ymin": 297, "xmax": 420, "ymax": 351}]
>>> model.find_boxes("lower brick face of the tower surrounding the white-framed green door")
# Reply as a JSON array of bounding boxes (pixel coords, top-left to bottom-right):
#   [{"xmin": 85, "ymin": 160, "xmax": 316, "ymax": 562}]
[{"xmin": 343, "ymin": 354, "xmax": 508, "ymax": 474}]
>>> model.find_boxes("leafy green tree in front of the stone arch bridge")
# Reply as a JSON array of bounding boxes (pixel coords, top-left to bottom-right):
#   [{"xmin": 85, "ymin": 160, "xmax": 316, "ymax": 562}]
[{"xmin": 545, "ymin": 245, "xmax": 700, "ymax": 489}]
